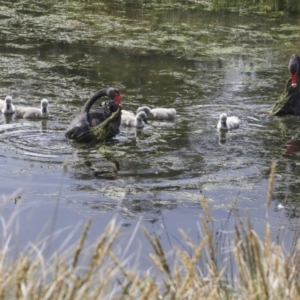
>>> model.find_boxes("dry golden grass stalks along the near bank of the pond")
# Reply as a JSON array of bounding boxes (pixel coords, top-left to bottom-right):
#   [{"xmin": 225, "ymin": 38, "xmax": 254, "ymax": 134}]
[{"xmin": 0, "ymin": 165, "xmax": 300, "ymax": 300}]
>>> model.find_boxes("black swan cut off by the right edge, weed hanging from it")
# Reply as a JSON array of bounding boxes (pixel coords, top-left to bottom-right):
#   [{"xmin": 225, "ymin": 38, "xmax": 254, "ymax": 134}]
[{"xmin": 270, "ymin": 54, "xmax": 300, "ymax": 116}]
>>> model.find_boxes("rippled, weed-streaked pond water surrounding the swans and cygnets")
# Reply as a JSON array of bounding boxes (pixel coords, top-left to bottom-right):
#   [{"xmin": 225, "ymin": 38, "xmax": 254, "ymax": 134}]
[{"xmin": 0, "ymin": 1, "xmax": 300, "ymax": 266}]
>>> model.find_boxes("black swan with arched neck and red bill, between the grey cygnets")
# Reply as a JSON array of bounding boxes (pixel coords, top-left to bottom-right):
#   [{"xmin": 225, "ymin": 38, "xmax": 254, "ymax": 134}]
[{"xmin": 65, "ymin": 87, "xmax": 122, "ymax": 142}]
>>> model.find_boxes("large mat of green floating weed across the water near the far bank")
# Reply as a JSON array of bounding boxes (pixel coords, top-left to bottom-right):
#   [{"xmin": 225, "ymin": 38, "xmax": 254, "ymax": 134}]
[{"xmin": 0, "ymin": 0, "xmax": 296, "ymax": 58}]
